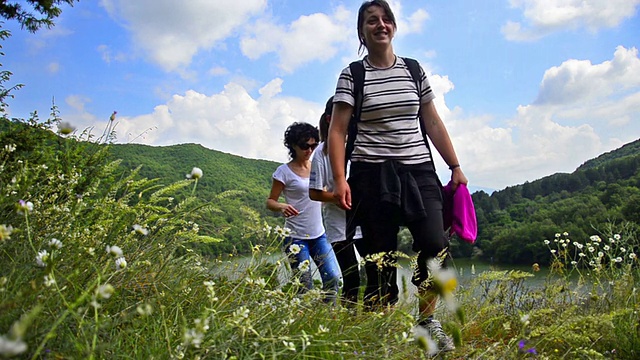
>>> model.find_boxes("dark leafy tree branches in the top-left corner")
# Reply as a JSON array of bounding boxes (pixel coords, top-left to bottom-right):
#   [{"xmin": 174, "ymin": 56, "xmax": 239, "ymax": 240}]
[{"xmin": 0, "ymin": 0, "xmax": 79, "ymax": 33}]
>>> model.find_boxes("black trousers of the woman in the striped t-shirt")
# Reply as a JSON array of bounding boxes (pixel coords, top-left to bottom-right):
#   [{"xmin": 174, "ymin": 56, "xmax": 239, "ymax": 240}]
[{"xmin": 347, "ymin": 163, "xmax": 449, "ymax": 305}]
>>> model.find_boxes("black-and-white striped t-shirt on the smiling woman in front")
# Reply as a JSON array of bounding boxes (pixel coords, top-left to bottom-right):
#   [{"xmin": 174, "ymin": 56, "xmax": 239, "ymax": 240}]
[{"xmin": 333, "ymin": 56, "xmax": 435, "ymax": 164}]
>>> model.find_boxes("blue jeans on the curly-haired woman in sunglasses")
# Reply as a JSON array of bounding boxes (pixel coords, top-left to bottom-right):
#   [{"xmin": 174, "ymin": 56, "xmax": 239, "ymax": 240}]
[{"xmin": 284, "ymin": 234, "xmax": 340, "ymax": 302}]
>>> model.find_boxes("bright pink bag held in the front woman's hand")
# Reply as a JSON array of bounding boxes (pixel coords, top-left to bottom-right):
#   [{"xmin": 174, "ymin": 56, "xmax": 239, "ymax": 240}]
[{"xmin": 442, "ymin": 181, "xmax": 478, "ymax": 244}]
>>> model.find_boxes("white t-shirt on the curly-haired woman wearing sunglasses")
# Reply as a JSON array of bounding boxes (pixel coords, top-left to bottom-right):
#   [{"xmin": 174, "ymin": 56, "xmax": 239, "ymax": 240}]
[{"xmin": 273, "ymin": 164, "xmax": 324, "ymax": 239}]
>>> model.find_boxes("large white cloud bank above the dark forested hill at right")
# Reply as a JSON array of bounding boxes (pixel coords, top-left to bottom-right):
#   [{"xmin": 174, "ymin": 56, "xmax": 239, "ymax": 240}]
[{"xmin": 439, "ymin": 47, "xmax": 640, "ymax": 188}]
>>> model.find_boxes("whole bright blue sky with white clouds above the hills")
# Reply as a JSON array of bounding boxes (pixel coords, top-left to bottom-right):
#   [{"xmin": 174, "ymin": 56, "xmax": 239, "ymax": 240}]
[{"xmin": 0, "ymin": 0, "xmax": 640, "ymax": 189}]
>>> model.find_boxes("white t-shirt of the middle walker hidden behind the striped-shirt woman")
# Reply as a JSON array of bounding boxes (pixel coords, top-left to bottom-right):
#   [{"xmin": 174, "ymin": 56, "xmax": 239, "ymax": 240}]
[{"xmin": 309, "ymin": 143, "xmax": 362, "ymax": 243}]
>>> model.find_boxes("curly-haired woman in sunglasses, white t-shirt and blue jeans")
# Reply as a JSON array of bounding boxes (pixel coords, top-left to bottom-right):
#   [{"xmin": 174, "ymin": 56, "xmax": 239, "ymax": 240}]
[{"xmin": 266, "ymin": 122, "xmax": 340, "ymax": 302}]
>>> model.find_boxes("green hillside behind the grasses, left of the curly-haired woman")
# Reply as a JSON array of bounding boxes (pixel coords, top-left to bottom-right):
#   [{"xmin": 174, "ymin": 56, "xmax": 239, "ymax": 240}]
[{"xmin": 109, "ymin": 144, "xmax": 282, "ymax": 255}]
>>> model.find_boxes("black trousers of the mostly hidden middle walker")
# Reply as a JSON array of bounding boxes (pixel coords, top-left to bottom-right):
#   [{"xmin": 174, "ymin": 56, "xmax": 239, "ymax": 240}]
[{"xmin": 331, "ymin": 240, "xmax": 360, "ymax": 305}]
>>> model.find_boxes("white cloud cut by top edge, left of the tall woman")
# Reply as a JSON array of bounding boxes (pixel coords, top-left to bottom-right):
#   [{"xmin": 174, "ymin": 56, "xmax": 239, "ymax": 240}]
[{"xmin": 101, "ymin": 0, "xmax": 266, "ymax": 71}]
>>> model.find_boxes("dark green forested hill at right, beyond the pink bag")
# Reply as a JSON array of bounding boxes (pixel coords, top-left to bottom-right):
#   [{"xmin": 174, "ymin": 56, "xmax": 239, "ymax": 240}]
[{"xmin": 468, "ymin": 140, "xmax": 640, "ymax": 264}]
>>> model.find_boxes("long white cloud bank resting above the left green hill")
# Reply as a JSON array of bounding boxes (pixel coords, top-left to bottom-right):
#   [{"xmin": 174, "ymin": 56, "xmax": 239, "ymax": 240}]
[{"xmin": 80, "ymin": 78, "xmax": 322, "ymax": 162}]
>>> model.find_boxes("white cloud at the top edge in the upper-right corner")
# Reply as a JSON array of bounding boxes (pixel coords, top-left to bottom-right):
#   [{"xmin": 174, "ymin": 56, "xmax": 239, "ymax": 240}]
[{"xmin": 502, "ymin": 0, "xmax": 640, "ymax": 41}]
